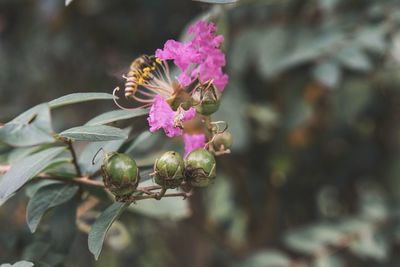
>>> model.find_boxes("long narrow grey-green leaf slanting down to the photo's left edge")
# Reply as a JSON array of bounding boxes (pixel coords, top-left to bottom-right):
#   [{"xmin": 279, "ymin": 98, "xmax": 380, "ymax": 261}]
[{"xmin": 0, "ymin": 147, "xmax": 65, "ymax": 205}]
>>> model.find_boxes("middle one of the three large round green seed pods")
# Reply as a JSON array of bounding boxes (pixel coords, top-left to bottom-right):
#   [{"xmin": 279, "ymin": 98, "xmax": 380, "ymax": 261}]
[{"xmin": 154, "ymin": 151, "xmax": 185, "ymax": 188}]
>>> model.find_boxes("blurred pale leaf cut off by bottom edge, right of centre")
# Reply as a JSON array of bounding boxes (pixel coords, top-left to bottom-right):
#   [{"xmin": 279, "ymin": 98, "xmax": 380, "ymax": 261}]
[{"xmin": 236, "ymin": 249, "xmax": 290, "ymax": 267}]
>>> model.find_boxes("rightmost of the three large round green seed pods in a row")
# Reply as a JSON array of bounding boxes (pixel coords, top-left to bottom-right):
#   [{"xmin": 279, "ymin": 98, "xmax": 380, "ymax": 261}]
[{"xmin": 185, "ymin": 148, "xmax": 216, "ymax": 187}]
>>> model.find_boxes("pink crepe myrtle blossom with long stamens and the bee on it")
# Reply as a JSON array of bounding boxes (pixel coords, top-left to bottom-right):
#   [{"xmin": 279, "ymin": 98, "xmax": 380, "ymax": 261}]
[{"xmin": 113, "ymin": 20, "xmax": 228, "ymax": 137}]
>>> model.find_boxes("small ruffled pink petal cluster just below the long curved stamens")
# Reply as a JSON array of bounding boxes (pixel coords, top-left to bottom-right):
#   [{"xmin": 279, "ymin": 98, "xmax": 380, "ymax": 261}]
[{"xmin": 147, "ymin": 95, "xmax": 196, "ymax": 137}]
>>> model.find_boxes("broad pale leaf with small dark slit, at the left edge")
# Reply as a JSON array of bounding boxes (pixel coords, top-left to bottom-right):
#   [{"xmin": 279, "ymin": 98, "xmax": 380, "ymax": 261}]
[{"xmin": 0, "ymin": 104, "xmax": 54, "ymax": 147}]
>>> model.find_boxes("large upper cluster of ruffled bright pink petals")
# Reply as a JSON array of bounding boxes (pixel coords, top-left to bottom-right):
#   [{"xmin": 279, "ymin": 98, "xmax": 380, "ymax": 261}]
[{"xmin": 155, "ymin": 20, "xmax": 228, "ymax": 92}]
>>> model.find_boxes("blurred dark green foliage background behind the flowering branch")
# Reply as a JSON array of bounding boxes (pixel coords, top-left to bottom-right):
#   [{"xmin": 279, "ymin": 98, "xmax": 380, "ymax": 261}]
[{"xmin": 0, "ymin": 0, "xmax": 400, "ymax": 267}]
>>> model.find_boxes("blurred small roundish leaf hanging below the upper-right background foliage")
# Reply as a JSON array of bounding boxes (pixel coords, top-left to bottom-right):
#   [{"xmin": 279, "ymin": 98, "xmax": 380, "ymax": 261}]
[{"xmin": 312, "ymin": 60, "xmax": 342, "ymax": 88}]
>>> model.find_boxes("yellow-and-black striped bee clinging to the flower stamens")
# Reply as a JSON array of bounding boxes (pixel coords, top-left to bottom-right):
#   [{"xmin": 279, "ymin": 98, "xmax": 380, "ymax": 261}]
[{"xmin": 123, "ymin": 55, "xmax": 161, "ymax": 98}]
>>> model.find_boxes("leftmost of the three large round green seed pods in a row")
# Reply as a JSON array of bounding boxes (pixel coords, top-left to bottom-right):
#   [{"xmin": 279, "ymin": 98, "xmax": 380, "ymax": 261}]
[{"xmin": 101, "ymin": 153, "xmax": 140, "ymax": 200}]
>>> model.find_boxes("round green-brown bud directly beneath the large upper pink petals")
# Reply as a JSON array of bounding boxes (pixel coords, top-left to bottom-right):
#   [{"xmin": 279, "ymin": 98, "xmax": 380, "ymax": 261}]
[{"xmin": 192, "ymin": 84, "xmax": 221, "ymax": 116}]
